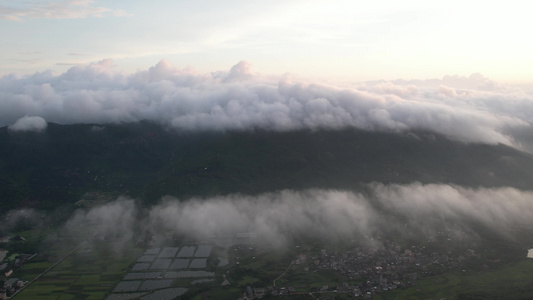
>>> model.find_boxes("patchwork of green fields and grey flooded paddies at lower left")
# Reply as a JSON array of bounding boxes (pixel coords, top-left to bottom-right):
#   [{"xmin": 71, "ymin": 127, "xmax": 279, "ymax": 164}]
[{"xmin": 10, "ymin": 243, "xmax": 215, "ymax": 300}]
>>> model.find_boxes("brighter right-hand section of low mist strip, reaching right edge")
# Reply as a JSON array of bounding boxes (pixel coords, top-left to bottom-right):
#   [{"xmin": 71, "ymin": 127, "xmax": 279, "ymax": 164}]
[{"xmin": 371, "ymin": 183, "xmax": 533, "ymax": 234}]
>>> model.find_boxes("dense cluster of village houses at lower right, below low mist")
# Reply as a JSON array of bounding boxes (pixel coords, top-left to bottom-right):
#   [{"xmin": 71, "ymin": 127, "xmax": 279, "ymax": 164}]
[{"xmin": 304, "ymin": 242, "xmax": 476, "ymax": 298}]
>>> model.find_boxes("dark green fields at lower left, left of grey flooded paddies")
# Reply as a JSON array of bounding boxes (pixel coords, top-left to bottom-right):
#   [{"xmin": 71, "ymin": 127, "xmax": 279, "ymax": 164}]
[{"xmin": 0, "ymin": 225, "xmax": 143, "ymax": 299}]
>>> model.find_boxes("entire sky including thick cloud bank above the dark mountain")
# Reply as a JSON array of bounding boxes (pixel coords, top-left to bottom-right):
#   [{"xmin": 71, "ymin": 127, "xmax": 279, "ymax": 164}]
[{"xmin": 0, "ymin": 0, "xmax": 533, "ymax": 152}]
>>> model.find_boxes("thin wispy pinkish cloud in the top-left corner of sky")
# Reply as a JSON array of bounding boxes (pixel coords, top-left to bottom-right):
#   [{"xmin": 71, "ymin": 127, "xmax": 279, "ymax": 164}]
[{"xmin": 0, "ymin": 0, "xmax": 128, "ymax": 21}]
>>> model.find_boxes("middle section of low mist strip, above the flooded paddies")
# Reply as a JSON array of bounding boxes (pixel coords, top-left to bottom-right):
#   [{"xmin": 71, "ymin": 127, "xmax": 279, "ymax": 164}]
[{"xmin": 148, "ymin": 190, "xmax": 373, "ymax": 246}]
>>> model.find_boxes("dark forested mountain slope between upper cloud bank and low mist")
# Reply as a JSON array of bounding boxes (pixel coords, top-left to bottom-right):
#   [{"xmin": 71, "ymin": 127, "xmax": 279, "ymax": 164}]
[{"xmin": 0, "ymin": 122, "xmax": 533, "ymax": 210}]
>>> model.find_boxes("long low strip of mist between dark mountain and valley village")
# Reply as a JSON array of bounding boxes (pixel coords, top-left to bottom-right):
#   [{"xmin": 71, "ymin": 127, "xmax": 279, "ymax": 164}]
[{"xmin": 62, "ymin": 183, "xmax": 533, "ymax": 250}]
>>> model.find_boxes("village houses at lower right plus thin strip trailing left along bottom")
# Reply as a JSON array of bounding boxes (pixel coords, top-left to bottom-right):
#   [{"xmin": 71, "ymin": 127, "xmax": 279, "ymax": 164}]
[{"xmin": 236, "ymin": 241, "xmax": 477, "ymax": 299}]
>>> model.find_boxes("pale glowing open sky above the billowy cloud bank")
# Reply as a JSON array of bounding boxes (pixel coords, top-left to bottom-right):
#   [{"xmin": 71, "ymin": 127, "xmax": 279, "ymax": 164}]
[{"xmin": 0, "ymin": 0, "xmax": 533, "ymax": 82}]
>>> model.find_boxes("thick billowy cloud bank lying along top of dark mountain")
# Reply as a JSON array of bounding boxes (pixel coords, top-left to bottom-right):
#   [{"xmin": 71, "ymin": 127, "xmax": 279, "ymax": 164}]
[{"xmin": 0, "ymin": 60, "xmax": 533, "ymax": 148}]
